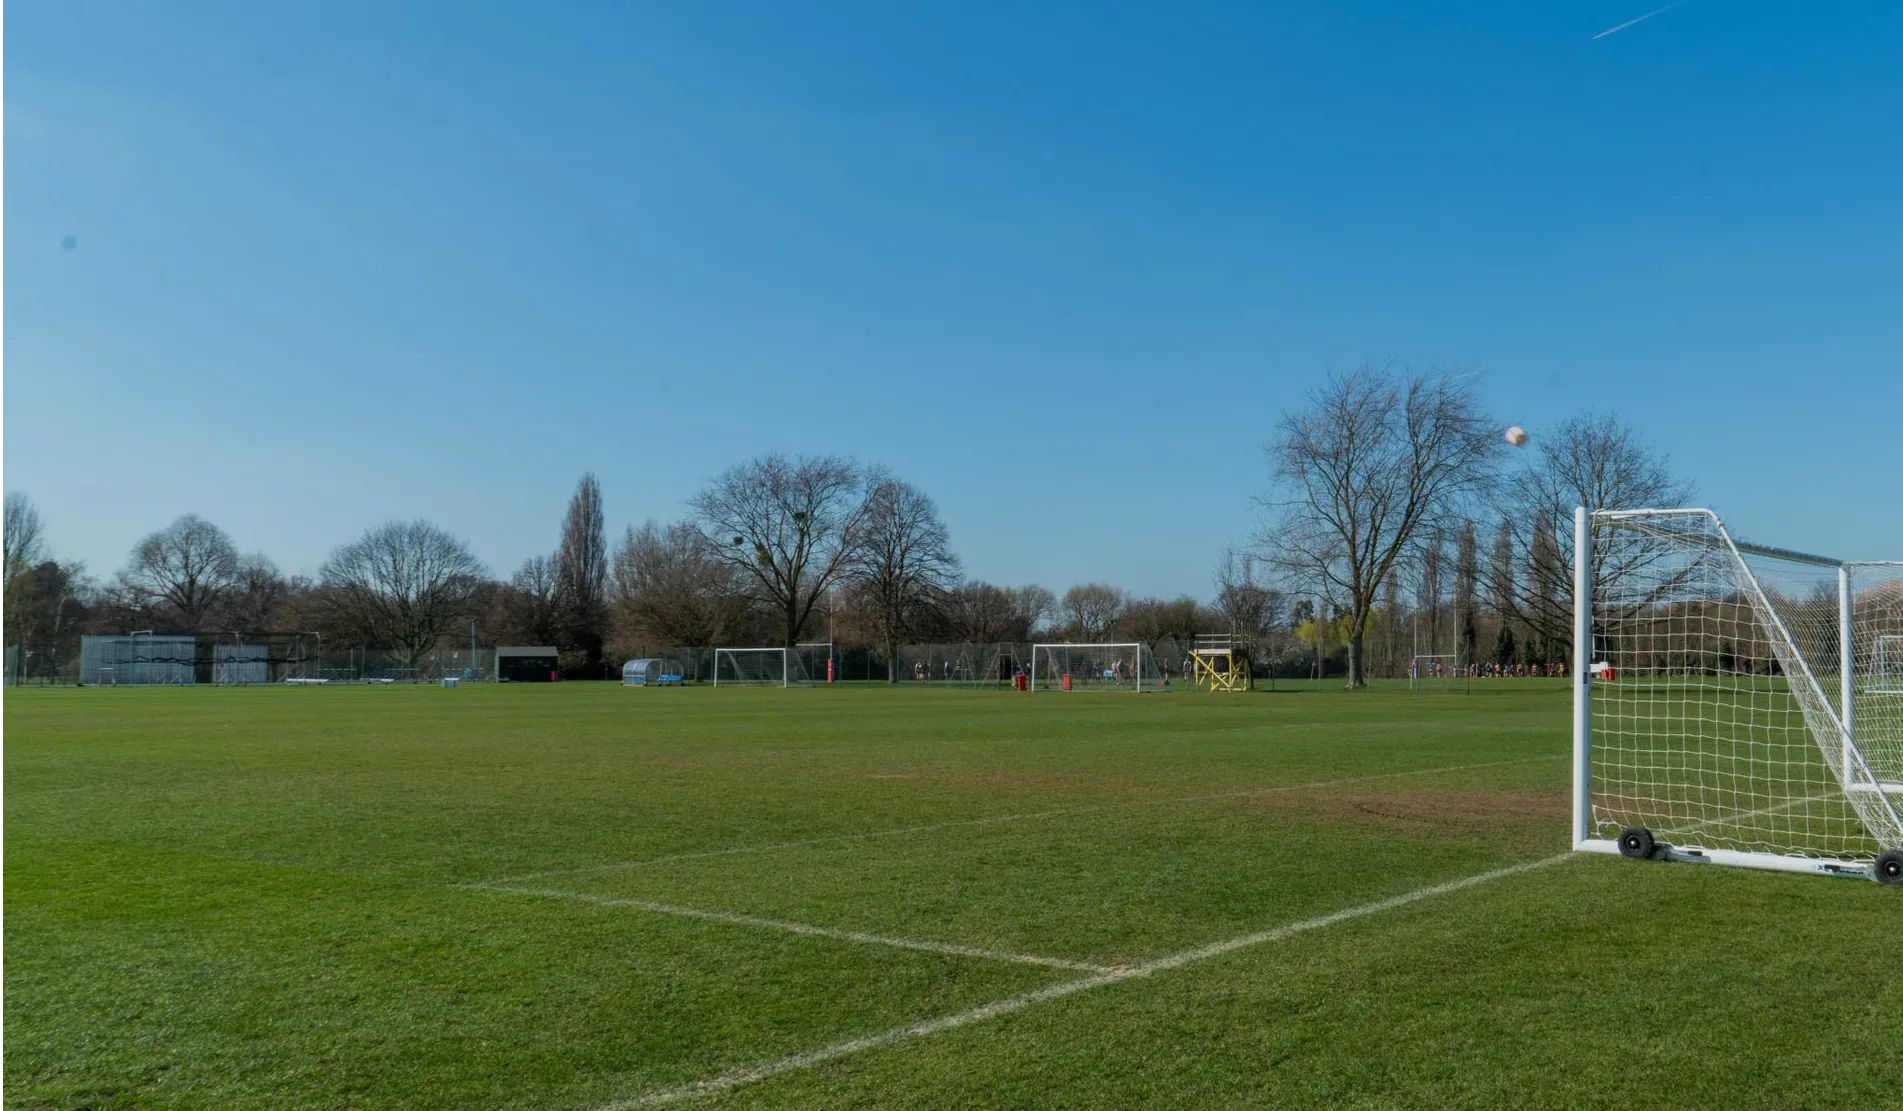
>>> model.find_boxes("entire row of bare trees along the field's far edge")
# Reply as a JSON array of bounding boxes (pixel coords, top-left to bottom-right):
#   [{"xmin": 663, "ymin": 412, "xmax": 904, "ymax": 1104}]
[{"xmin": 6, "ymin": 365, "xmax": 1692, "ymax": 685}]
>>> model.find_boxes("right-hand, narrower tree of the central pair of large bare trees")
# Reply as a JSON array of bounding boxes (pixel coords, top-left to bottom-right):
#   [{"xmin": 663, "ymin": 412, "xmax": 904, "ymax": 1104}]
[{"xmin": 853, "ymin": 478, "xmax": 959, "ymax": 683}]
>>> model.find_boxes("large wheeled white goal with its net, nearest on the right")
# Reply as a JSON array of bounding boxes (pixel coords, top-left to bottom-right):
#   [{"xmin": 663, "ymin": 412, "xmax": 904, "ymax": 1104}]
[{"xmin": 1572, "ymin": 510, "xmax": 1903, "ymax": 885}]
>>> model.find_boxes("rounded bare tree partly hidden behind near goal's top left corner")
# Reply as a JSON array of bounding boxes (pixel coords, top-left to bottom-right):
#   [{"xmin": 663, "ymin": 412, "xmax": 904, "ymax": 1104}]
[{"xmin": 1488, "ymin": 413, "xmax": 1694, "ymax": 658}]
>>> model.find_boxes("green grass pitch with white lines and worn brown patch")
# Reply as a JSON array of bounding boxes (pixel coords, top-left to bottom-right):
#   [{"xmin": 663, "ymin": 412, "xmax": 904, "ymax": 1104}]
[{"xmin": 6, "ymin": 681, "xmax": 1903, "ymax": 1111}]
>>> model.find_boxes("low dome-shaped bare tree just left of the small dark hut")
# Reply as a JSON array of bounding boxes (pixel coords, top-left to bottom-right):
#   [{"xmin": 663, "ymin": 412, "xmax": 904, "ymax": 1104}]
[{"xmin": 320, "ymin": 521, "xmax": 483, "ymax": 668}]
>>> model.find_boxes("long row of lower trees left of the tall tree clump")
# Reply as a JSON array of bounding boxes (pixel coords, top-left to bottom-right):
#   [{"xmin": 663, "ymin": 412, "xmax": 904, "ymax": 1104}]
[{"xmin": 6, "ymin": 455, "xmax": 1212, "ymax": 677}]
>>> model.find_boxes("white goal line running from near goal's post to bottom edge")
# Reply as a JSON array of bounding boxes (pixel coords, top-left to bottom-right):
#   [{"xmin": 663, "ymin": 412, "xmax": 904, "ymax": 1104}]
[{"xmin": 596, "ymin": 852, "xmax": 1576, "ymax": 1111}]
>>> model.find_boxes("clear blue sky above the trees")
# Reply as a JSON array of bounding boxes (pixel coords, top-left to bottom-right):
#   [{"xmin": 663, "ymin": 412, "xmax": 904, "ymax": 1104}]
[{"xmin": 6, "ymin": 0, "xmax": 1903, "ymax": 595}]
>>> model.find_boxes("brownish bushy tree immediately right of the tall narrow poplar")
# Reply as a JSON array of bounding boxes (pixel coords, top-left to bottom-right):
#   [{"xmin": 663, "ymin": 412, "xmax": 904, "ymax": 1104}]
[{"xmin": 611, "ymin": 521, "xmax": 748, "ymax": 649}]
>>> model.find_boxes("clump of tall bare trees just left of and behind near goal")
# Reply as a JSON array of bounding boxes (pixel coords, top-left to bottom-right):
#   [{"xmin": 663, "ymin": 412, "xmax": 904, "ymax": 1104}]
[{"xmin": 1258, "ymin": 363, "xmax": 1694, "ymax": 687}]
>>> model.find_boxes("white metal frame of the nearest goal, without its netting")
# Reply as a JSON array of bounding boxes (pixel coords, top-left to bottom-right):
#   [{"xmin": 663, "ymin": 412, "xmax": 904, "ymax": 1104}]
[{"xmin": 1570, "ymin": 508, "xmax": 1903, "ymax": 877}]
